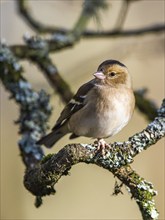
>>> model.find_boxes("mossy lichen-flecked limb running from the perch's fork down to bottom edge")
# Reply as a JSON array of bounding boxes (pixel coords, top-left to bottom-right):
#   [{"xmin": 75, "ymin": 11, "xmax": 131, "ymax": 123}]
[{"xmin": 114, "ymin": 165, "xmax": 159, "ymax": 220}]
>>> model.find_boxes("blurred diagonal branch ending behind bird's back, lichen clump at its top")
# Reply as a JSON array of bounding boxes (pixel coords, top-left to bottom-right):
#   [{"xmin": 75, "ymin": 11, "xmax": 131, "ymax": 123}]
[{"xmin": 11, "ymin": 36, "xmax": 73, "ymax": 103}]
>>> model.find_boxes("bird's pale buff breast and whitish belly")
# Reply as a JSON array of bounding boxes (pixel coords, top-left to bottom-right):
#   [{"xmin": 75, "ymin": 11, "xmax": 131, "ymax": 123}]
[{"xmin": 68, "ymin": 85, "xmax": 134, "ymax": 138}]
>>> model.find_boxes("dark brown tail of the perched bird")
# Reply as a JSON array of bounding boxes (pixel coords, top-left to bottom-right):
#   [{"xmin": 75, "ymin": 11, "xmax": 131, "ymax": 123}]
[{"xmin": 37, "ymin": 131, "xmax": 66, "ymax": 148}]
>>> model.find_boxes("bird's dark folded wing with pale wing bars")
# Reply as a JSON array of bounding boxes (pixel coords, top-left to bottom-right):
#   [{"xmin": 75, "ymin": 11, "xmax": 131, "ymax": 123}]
[{"xmin": 52, "ymin": 80, "xmax": 95, "ymax": 130}]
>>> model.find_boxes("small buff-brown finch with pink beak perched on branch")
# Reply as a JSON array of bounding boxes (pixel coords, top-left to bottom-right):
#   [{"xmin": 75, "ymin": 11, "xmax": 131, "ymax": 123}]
[{"xmin": 37, "ymin": 59, "xmax": 135, "ymax": 150}]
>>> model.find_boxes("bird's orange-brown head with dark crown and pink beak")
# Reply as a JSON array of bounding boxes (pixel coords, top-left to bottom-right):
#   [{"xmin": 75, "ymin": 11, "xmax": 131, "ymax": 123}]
[{"xmin": 93, "ymin": 60, "xmax": 131, "ymax": 88}]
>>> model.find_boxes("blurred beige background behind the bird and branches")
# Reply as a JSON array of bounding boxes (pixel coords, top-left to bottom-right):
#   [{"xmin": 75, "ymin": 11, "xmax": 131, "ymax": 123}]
[{"xmin": 0, "ymin": 0, "xmax": 165, "ymax": 220}]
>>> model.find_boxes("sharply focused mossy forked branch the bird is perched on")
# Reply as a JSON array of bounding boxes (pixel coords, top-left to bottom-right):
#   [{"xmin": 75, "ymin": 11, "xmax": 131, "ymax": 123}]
[{"xmin": 24, "ymin": 100, "xmax": 165, "ymax": 219}]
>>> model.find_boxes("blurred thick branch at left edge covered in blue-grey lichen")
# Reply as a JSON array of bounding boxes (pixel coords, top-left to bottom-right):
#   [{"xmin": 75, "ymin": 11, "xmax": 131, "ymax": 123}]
[{"xmin": 0, "ymin": 45, "xmax": 51, "ymax": 167}]
